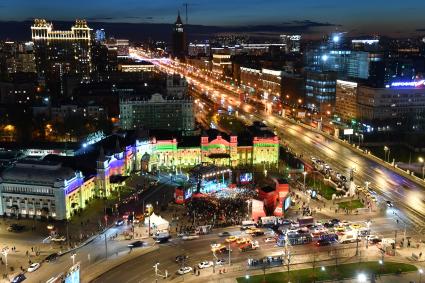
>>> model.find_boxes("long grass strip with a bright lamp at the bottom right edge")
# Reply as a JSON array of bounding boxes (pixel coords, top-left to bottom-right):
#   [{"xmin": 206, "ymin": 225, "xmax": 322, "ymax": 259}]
[{"xmin": 237, "ymin": 261, "xmax": 418, "ymax": 283}]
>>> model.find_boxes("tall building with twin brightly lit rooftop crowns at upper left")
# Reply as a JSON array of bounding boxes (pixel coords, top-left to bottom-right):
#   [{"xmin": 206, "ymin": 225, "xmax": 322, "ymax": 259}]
[{"xmin": 31, "ymin": 19, "xmax": 91, "ymax": 95}]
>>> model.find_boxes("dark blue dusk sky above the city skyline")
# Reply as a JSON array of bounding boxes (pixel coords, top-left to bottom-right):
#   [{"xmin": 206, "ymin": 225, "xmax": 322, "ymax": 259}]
[{"xmin": 0, "ymin": 0, "xmax": 425, "ymax": 34}]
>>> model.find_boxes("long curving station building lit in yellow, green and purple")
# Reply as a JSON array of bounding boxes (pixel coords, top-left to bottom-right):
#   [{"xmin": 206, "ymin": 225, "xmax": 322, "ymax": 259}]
[{"xmin": 0, "ymin": 125, "xmax": 279, "ymax": 220}]
